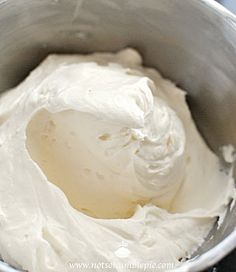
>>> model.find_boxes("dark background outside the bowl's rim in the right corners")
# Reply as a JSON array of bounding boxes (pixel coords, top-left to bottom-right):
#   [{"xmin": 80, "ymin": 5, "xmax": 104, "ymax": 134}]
[{"xmin": 204, "ymin": 0, "xmax": 236, "ymax": 272}]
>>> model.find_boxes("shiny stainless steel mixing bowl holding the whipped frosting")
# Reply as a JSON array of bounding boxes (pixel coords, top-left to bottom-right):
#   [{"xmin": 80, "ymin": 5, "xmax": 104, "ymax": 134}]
[{"xmin": 0, "ymin": 0, "xmax": 236, "ymax": 272}]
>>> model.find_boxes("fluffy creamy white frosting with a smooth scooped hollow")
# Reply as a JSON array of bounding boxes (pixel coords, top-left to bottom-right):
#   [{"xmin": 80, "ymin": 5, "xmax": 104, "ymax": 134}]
[{"xmin": 0, "ymin": 49, "xmax": 235, "ymax": 272}]
